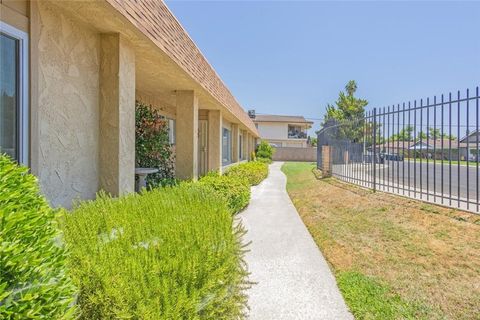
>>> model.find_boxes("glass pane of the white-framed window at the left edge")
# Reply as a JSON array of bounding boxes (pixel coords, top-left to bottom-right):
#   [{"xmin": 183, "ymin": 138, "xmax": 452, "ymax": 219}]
[{"xmin": 0, "ymin": 33, "xmax": 19, "ymax": 159}]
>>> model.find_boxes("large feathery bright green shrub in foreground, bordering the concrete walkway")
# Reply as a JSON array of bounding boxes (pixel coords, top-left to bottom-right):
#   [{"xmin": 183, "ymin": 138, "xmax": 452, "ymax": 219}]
[{"xmin": 62, "ymin": 183, "xmax": 246, "ymax": 319}]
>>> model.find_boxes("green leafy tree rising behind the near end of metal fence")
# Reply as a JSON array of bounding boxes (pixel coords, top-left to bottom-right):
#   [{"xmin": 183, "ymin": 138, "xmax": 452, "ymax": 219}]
[{"xmin": 322, "ymin": 80, "xmax": 368, "ymax": 141}]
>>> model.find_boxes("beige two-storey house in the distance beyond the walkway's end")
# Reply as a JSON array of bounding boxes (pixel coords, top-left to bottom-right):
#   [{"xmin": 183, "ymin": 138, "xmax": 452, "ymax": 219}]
[{"xmin": 251, "ymin": 112, "xmax": 313, "ymax": 148}]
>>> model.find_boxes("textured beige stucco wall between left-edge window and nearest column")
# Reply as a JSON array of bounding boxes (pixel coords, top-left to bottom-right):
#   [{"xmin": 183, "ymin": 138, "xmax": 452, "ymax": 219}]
[{"xmin": 35, "ymin": 1, "xmax": 100, "ymax": 207}]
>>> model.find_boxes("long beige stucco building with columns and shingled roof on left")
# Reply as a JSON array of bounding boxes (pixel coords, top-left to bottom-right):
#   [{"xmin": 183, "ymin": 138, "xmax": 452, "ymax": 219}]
[{"xmin": 0, "ymin": 0, "xmax": 258, "ymax": 207}]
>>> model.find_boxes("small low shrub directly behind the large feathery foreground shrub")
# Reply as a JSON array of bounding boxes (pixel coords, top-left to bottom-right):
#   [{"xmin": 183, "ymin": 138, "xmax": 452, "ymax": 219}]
[{"xmin": 198, "ymin": 172, "xmax": 250, "ymax": 213}]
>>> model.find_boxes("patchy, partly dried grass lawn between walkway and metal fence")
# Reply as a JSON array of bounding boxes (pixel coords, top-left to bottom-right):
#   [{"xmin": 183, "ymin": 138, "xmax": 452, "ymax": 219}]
[{"xmin": 282, "ymin": 163, "xmax": 480, "ymax": 319}]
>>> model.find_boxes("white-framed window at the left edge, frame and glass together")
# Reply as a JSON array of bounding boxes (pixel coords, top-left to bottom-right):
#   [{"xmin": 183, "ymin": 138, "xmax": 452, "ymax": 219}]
[{"xmin": 0, "ymin": 22, "xmax": 28, "ymax": 164}]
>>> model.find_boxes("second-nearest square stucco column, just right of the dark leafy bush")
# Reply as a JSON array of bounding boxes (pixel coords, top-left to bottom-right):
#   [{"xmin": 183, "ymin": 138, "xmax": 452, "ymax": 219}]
[{"xmin": 175, "ymin": 90, "xmax": 198, "ymax": 180}]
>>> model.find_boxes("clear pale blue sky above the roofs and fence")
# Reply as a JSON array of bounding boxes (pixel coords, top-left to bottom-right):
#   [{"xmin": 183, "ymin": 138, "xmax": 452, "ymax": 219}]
[{"xmin": 167, "ymin": 1, "xmax": 480, "ymax": 133}]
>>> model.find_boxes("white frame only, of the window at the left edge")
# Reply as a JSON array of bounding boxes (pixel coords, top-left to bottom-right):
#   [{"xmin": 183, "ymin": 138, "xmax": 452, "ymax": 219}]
[{"xmin": 0, "ymin": 21, "xmax": 30, "ymax": 166}]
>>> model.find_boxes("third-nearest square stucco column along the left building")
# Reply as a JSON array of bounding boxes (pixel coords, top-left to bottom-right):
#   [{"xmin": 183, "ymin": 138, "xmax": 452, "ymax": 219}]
[{"xmin": 208, "ymin": 110, "xmax": 222, "ymax": 173}]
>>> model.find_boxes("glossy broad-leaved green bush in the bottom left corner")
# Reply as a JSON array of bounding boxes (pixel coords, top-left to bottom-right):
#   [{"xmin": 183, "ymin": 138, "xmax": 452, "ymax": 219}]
[{"xmin": 0, "ymin": 154, "xmax": 75, "ymax": 319}]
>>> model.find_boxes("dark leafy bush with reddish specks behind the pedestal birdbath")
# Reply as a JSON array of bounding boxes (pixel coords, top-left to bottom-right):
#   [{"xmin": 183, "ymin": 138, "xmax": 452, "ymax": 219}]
[{"xmin": 135, "ymin": 101, "xmax": 175, "ymax": 188}]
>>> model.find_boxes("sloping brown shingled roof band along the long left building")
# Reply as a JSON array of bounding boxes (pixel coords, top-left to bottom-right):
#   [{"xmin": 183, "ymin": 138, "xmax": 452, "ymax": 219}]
[{"xmin": 103, "ymin": 0, "xmax": 258, "ymax": 135}]
